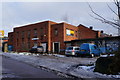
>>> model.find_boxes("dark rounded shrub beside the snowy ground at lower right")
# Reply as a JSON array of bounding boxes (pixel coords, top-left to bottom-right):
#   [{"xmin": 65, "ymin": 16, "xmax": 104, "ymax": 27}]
[{"xmin": 94, "ymin": 51, "xmax": 120, "ymax": 74}]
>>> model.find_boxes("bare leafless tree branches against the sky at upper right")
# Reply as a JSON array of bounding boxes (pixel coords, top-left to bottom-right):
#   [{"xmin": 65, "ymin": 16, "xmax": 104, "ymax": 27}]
[{"xmin": 88, "ymin": 0, "xmax": 120, "ymax": 36}]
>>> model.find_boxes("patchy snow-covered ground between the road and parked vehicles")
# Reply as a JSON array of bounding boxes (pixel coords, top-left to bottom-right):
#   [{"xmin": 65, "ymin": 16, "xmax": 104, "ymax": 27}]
[{"xmin": 2, "ymin": 53, "xmax": 120, "ymax": 78}]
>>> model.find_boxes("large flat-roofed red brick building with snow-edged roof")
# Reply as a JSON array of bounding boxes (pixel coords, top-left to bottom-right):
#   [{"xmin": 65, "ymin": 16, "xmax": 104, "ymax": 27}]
[{"xmin": 8, "ymin": 21, "xmax": 105, "ymax": 53}]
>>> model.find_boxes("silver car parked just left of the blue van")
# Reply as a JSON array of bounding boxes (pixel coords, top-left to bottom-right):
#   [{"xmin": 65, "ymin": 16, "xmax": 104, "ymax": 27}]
[{"xmin": 65, "ymin": 46, "xmax": 80, "ymax": 56}]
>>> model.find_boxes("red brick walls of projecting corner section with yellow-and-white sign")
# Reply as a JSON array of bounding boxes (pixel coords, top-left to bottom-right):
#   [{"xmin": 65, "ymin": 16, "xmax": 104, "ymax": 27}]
[{"xmin": 51, "ymin": 23, "xmax": 78, "ymax": 49}]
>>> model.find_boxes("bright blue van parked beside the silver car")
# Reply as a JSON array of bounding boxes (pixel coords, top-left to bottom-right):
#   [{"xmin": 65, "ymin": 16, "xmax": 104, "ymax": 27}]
[{"xmin": 79, "ymin": 43, "xmax": 101, "ymax": 57}]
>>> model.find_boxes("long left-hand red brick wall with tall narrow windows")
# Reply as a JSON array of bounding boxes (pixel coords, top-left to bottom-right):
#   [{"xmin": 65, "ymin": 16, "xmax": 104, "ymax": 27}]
[{"xmin": 11, "ymin": 21, "xmax": 57, "ymax": 50}]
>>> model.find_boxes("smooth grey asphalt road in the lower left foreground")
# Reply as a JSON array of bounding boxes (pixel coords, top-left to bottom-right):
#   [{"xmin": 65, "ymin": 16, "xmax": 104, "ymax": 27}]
[{"xmin": 2, "ymin": 56, "xmax": 61, "ymax": 78}]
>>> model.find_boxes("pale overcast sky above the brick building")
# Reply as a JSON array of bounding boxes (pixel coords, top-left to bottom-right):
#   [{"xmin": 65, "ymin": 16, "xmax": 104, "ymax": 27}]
[{"xmin": 0, "ymin": 2, "xmax": 117, "ymax": 35}]
